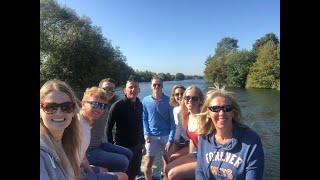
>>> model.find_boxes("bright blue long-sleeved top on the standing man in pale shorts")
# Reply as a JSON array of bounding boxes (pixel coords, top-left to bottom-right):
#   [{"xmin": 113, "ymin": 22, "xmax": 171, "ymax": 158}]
[{"xmin": 142, "ymin": 94, "xmax": 176, "ymax": 142}]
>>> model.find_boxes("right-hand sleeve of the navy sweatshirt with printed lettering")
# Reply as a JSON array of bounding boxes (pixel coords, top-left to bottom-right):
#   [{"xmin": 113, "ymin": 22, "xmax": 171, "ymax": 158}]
[{"xmin": 246, "ymin": 135, "xmax": 264, "ymax": 180}]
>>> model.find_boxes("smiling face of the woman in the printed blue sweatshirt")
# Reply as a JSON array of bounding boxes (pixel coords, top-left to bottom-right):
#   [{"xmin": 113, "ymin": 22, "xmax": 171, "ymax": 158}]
[{"xmin": 207, "ymin": 96, "xmax": 233, "ymax": 131}]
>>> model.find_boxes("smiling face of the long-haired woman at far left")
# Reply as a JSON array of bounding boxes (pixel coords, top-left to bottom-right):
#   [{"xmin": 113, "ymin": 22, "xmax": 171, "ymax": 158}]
[{"xmin": 40, "ymin": 90, "xmax": 75, "ymax": 140}]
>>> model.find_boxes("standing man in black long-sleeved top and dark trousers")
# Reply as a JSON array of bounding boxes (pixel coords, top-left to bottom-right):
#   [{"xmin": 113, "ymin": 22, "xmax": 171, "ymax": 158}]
[{"xmin": 107, "ymin": 80, "xmax": 145, "ymax": 180}]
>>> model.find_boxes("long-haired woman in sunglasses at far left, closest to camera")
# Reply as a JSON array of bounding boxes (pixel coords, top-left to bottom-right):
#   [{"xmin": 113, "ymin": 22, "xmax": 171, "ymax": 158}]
[{"xmin": 40, "ymin": 80, "xmax": 81, "ymax": 180}]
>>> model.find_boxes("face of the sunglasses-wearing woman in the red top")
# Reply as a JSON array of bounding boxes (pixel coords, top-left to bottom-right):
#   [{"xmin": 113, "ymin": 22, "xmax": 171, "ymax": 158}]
[{"xmin": 183, "ymin": 89, "xmax": 201, "ymax": 113}]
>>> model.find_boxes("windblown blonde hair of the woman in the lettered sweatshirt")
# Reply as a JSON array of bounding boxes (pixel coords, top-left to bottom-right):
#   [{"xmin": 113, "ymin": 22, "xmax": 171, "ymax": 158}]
[{"xmin": 197, "ymin": 84, "xmax": 249, "ymax": 136}]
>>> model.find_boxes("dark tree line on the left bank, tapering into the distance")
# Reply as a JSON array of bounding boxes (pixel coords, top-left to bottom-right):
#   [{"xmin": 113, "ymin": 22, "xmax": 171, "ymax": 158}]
[{"xmin": 40, "ymin": 0, "xmax": 201, "ymax": 97}]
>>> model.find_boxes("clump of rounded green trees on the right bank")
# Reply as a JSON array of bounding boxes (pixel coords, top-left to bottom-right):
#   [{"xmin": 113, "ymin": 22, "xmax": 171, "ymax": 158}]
[{"xmin": 204, "ymin": 33, "xmax": 280, "ymax": 89}]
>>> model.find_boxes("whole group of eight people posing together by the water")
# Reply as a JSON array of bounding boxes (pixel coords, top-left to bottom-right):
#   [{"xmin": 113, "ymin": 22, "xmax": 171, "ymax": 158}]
[{"xmin": 40, "ymin": 75, "xmax": 264, "ymax": 180}]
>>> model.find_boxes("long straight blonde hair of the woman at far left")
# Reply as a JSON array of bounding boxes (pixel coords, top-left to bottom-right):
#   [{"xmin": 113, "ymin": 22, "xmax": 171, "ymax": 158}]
[{"xmin": 40, "ymin": 79, "xmax": 81, "ymax": 179}]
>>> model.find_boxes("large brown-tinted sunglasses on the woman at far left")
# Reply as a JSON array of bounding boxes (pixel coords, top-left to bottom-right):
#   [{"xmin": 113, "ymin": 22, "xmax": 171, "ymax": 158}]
[{"xmin": 40, "ymin": 102, "xmax": 75, "ymax": 114}]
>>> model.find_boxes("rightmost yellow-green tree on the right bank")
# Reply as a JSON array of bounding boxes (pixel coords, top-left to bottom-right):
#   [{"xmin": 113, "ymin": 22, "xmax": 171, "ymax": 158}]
[{"xmin": 246, "ymin": 44, "xmax": 280, "ymax": 89}]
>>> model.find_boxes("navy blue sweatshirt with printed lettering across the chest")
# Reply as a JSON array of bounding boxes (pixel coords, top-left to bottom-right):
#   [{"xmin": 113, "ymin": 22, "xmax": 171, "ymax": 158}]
[{"xmin": 196, "ymin": 125, "xmax": 264, "ymax": 180}]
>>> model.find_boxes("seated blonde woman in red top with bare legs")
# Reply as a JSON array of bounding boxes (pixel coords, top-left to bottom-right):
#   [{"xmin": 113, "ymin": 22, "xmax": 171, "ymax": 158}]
[{"xmin": 165, "ymin": 85, "xmax": 204, "ymax": 180}]
